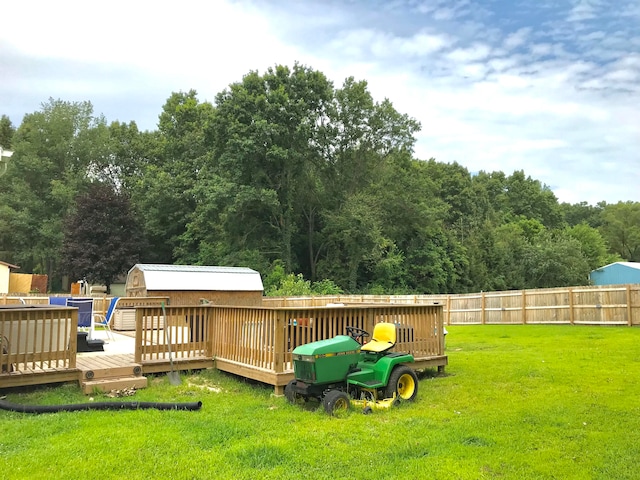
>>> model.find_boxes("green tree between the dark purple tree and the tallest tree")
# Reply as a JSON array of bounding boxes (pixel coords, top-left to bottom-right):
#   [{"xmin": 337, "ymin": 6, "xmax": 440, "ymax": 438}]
[{"xmin": 135, "ymin": 90, "xmax": 214, "ymax": 263}]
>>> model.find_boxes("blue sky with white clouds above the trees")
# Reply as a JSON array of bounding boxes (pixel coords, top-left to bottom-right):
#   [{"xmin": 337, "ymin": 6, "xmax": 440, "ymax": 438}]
[{"xmin": 0, "ymin": 0, "xmax": 640, "ymax": 205}]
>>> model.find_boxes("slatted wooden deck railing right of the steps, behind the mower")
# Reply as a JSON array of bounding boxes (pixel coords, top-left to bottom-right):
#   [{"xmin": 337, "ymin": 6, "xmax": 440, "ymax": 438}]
[{"xmin": 135, "ymin": 305, "xmax": 447, "ymax": 391}]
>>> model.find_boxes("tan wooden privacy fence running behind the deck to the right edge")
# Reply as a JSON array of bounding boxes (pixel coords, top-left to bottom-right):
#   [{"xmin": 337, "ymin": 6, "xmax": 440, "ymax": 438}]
[{"xmin": 263, "ymin": 284, "xmax": 640, "ymax": 326}]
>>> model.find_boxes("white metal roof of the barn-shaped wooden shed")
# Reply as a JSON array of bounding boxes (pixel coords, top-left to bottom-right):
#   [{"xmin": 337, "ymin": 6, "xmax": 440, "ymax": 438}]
[{"xmin": 129, "ymin": 263, "xmax": 263, "ymax": 292}]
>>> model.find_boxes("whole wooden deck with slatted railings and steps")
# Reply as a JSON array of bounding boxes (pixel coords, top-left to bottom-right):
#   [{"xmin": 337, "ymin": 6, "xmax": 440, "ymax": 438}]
[{"xmin": 0, "ymin": 305, "xmax": 447, "ymax": 394}]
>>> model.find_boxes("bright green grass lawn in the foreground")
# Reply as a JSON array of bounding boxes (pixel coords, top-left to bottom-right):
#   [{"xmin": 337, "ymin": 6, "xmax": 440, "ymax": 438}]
[{"xmin": 0, "ymin": 326, "xmax": 640, "ymax": 480}]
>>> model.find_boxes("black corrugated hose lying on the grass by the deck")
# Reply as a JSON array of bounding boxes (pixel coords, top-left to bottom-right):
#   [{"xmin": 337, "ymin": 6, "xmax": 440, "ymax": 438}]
[{"xmin": 0, "ymin": 400, "xmax": 202, "ymax": 413}]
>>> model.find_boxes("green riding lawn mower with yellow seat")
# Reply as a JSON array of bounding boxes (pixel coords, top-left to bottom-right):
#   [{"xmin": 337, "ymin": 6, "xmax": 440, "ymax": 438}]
[{"xmin": 284, "ymin": 323, "xmax": 418, "ymax": 415}]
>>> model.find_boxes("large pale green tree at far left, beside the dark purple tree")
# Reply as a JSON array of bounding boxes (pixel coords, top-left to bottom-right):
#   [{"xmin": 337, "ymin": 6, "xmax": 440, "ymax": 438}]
[{"xmin": 0, "ymin": 99, "xmax": 105, "ymax": 288}]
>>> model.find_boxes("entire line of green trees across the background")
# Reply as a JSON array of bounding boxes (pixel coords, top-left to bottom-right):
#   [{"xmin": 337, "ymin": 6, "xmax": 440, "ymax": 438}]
[{"xmin": 0, "ymin": 64, "xmax": 640, "ymax": 294}]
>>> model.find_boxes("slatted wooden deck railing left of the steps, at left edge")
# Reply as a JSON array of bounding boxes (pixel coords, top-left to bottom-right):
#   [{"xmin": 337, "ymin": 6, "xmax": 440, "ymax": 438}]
[{"xmin": 0, "ymin": 306, "xmax": 78, "ymax": 387}]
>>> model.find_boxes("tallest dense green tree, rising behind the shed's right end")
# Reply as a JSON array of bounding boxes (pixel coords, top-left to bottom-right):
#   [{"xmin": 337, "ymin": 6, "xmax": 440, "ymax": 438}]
[{"xmin": 188, "ymin": 64, "xmax": 332, "ymax": 271}]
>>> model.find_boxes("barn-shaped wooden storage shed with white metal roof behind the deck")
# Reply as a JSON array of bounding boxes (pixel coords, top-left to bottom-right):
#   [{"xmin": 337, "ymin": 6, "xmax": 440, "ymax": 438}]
[{"xmin": 126, "ymin": 263, "xmax": 263, "ymax": 307}]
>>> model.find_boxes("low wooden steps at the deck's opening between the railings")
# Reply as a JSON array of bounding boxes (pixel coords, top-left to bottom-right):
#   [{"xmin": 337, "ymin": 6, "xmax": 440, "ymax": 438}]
[{"xmin": 77, "ymin": 354, "xmax": 147, "ymax": 394}]
